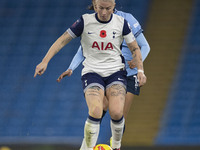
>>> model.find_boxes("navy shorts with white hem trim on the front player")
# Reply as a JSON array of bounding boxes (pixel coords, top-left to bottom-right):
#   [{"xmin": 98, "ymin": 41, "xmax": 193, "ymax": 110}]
[{"xmin": 81, "ymin": 71, "xmax": 127, "ymax": 93}]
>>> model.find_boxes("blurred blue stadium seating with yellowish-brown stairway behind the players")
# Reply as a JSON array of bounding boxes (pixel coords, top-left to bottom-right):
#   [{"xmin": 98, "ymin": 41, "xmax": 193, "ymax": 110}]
[{"xmin": 0, "ymin": 0, "xmax": 200, "ymax": 150}]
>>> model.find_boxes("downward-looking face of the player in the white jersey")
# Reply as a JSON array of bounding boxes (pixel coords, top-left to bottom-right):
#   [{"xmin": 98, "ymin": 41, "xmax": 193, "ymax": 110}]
[{"xmin": 96, "ymin": 0, "xmax": 115, "ymax": 21}]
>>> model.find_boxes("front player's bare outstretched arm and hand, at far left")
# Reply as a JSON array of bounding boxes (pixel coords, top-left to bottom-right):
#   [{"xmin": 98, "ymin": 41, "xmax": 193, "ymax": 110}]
[{"xmin": 34, "ymin": 31, "xmax": 72, "ymax": 77}]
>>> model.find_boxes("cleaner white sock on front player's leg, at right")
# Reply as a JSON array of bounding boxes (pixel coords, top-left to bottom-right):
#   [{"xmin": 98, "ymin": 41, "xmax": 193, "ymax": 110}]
[{"xmin": 110, "ymin": 117, "xmax": 125, "ymax": 149}]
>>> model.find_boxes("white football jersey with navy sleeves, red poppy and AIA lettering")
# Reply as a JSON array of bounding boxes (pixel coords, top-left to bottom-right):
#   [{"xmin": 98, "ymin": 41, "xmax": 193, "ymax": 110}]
[{"xmin": 67, "ymin": 14, "xmax": 135, "ymax": 77}]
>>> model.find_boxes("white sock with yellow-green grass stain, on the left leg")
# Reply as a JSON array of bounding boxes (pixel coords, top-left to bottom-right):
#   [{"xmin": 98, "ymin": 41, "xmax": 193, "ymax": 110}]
[{"xmin": 80, "ymin": 118, "xmax": 100, "ymax": 150}]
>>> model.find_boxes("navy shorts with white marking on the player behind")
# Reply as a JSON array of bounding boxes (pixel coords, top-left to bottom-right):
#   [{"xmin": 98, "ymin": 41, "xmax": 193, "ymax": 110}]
[{"xmin": 127, "ymin": 74, "xmax": 140, "ymax": 95}]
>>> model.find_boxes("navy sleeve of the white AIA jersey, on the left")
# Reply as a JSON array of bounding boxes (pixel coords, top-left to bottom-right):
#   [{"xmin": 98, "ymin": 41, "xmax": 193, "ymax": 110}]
[{"xmin": 70, "ymin": 17, "xmax": 84, "ymax": 37}]
